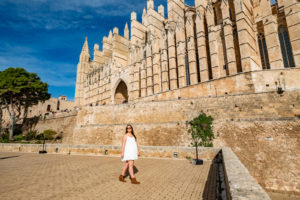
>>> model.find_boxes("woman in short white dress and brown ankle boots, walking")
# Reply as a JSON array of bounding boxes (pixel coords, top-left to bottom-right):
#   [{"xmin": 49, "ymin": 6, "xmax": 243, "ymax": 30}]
[{"xmin": 119, "ymin": 124, "xmax": 140, "ymax": 184}]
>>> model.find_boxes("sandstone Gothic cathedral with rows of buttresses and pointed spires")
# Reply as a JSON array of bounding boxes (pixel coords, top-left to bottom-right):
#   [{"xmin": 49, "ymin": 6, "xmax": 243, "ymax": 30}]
[{"xmin": 75, "ymin": 0, "xmax": 300, "ymax": 106}]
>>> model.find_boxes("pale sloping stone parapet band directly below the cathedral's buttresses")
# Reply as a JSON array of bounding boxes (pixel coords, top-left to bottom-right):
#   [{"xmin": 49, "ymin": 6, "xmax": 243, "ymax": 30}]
[{"xmin": 135, "ymin": 68, "xmax": 300, "ymax": 103}]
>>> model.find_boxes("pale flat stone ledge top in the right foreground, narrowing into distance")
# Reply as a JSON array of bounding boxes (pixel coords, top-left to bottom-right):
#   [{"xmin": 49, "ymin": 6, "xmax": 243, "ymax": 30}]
[{"xmin": 222, "ymin": 147, "xmax": 270, "ymax": 200}]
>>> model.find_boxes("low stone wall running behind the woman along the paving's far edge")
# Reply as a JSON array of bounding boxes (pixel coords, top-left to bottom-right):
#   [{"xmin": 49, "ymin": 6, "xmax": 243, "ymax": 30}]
[{"xmin": 0, "ymin": 143, "xmax": 220, "ymax": 160}]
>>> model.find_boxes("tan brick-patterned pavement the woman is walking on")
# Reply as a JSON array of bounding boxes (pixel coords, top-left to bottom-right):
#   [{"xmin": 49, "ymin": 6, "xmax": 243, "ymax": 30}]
[{"xmin": 0, "ymin": 153, "xmax": 211, "ymax": 200}]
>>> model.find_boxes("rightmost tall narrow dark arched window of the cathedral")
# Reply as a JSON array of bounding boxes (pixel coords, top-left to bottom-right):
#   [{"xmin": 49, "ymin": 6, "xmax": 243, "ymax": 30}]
[{"xmin": 278, "ymin": 26, "xmax": 295, "ymax": 68}]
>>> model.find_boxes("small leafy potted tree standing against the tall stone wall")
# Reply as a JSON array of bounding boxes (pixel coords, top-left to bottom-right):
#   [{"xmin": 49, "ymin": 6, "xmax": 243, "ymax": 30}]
[{"xmin": 188, "ymin": 113, "xmax": 215, "ymax": 161}]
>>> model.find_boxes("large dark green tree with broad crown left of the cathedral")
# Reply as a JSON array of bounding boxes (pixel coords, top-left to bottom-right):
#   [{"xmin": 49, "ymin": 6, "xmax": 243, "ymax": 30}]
[{"xmin": 0, "ymin": 68, "xmax": 50, "ymax": 140}]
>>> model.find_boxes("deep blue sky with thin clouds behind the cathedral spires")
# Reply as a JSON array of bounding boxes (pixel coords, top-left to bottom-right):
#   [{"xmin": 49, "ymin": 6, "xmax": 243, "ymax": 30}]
[{"xmin": 0, "ymin": 0, "xmax": 194, "ymax": 100}]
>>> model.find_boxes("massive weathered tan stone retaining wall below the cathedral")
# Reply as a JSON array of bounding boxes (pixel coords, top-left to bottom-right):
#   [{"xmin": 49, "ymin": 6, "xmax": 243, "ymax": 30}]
[{"xmin": 18, "ymin": 91, "xmax": 300, "ymax": 193}]
